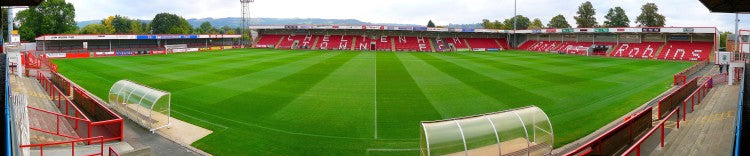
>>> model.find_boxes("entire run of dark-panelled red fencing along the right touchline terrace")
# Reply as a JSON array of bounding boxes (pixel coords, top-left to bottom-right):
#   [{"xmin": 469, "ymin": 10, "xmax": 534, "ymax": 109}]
[{"xmin": 565, "ymin": 77, "xmax": 714, "ymax": 156}]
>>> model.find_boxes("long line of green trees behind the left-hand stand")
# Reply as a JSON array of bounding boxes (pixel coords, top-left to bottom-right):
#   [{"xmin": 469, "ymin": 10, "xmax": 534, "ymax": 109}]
[{"xmin": 13, "ymin": 0, "xmax": 240, "ymax": 41}]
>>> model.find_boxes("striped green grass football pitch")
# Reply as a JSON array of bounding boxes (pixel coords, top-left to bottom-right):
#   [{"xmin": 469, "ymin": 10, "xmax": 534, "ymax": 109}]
[{"xmin": 53, "ymin": 49, "xmax": 693, "ymax": 155}]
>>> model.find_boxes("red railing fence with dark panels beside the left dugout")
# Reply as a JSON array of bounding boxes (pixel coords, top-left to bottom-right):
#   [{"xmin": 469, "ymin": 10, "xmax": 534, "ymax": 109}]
[{"xmin": 30, "ymin": 72, "xmax": 123, "ymax": 143}]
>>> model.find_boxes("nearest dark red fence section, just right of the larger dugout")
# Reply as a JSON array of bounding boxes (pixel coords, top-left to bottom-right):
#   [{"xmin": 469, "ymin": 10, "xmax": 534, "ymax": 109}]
[{"xmin": 565, "ymin": 107, "xmax": 653, "ymax": 156}]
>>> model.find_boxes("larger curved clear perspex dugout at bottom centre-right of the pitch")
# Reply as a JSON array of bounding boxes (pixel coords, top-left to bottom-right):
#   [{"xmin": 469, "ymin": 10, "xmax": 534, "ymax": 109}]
[{"xmin": 420, "ymin": 106, "xmax": 554, "ymax": 156}]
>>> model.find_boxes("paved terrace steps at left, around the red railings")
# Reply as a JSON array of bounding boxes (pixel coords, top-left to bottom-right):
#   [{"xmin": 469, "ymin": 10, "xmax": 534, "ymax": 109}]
[{"xmin": 10, "ymin": 71, "xmax": 200, "ymax": 156}]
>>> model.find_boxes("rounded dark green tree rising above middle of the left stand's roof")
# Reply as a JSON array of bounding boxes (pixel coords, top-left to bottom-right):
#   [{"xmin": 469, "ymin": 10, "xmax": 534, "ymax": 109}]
[{"xmin": 150, "ymin": 13, "xmax": 193, "ymax": 34}]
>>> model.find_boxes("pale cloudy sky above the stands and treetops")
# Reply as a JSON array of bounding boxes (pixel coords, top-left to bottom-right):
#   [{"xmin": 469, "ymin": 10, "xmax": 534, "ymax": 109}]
[{"xmin": 60, "ymin": 0, "xmax": 750, "ymax": 31}]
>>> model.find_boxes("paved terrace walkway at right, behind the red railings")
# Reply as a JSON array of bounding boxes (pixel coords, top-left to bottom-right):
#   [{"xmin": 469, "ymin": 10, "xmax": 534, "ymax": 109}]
[{"xmin": 642, "ymin": 66, "xmax": 740, "ymax": 155}]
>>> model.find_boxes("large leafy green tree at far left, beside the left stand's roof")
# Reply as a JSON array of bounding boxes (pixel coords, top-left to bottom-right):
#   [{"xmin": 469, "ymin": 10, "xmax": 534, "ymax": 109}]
[{"xmin": 15, "ymin": 0, "xmax": 78, "ymax": 41}]
